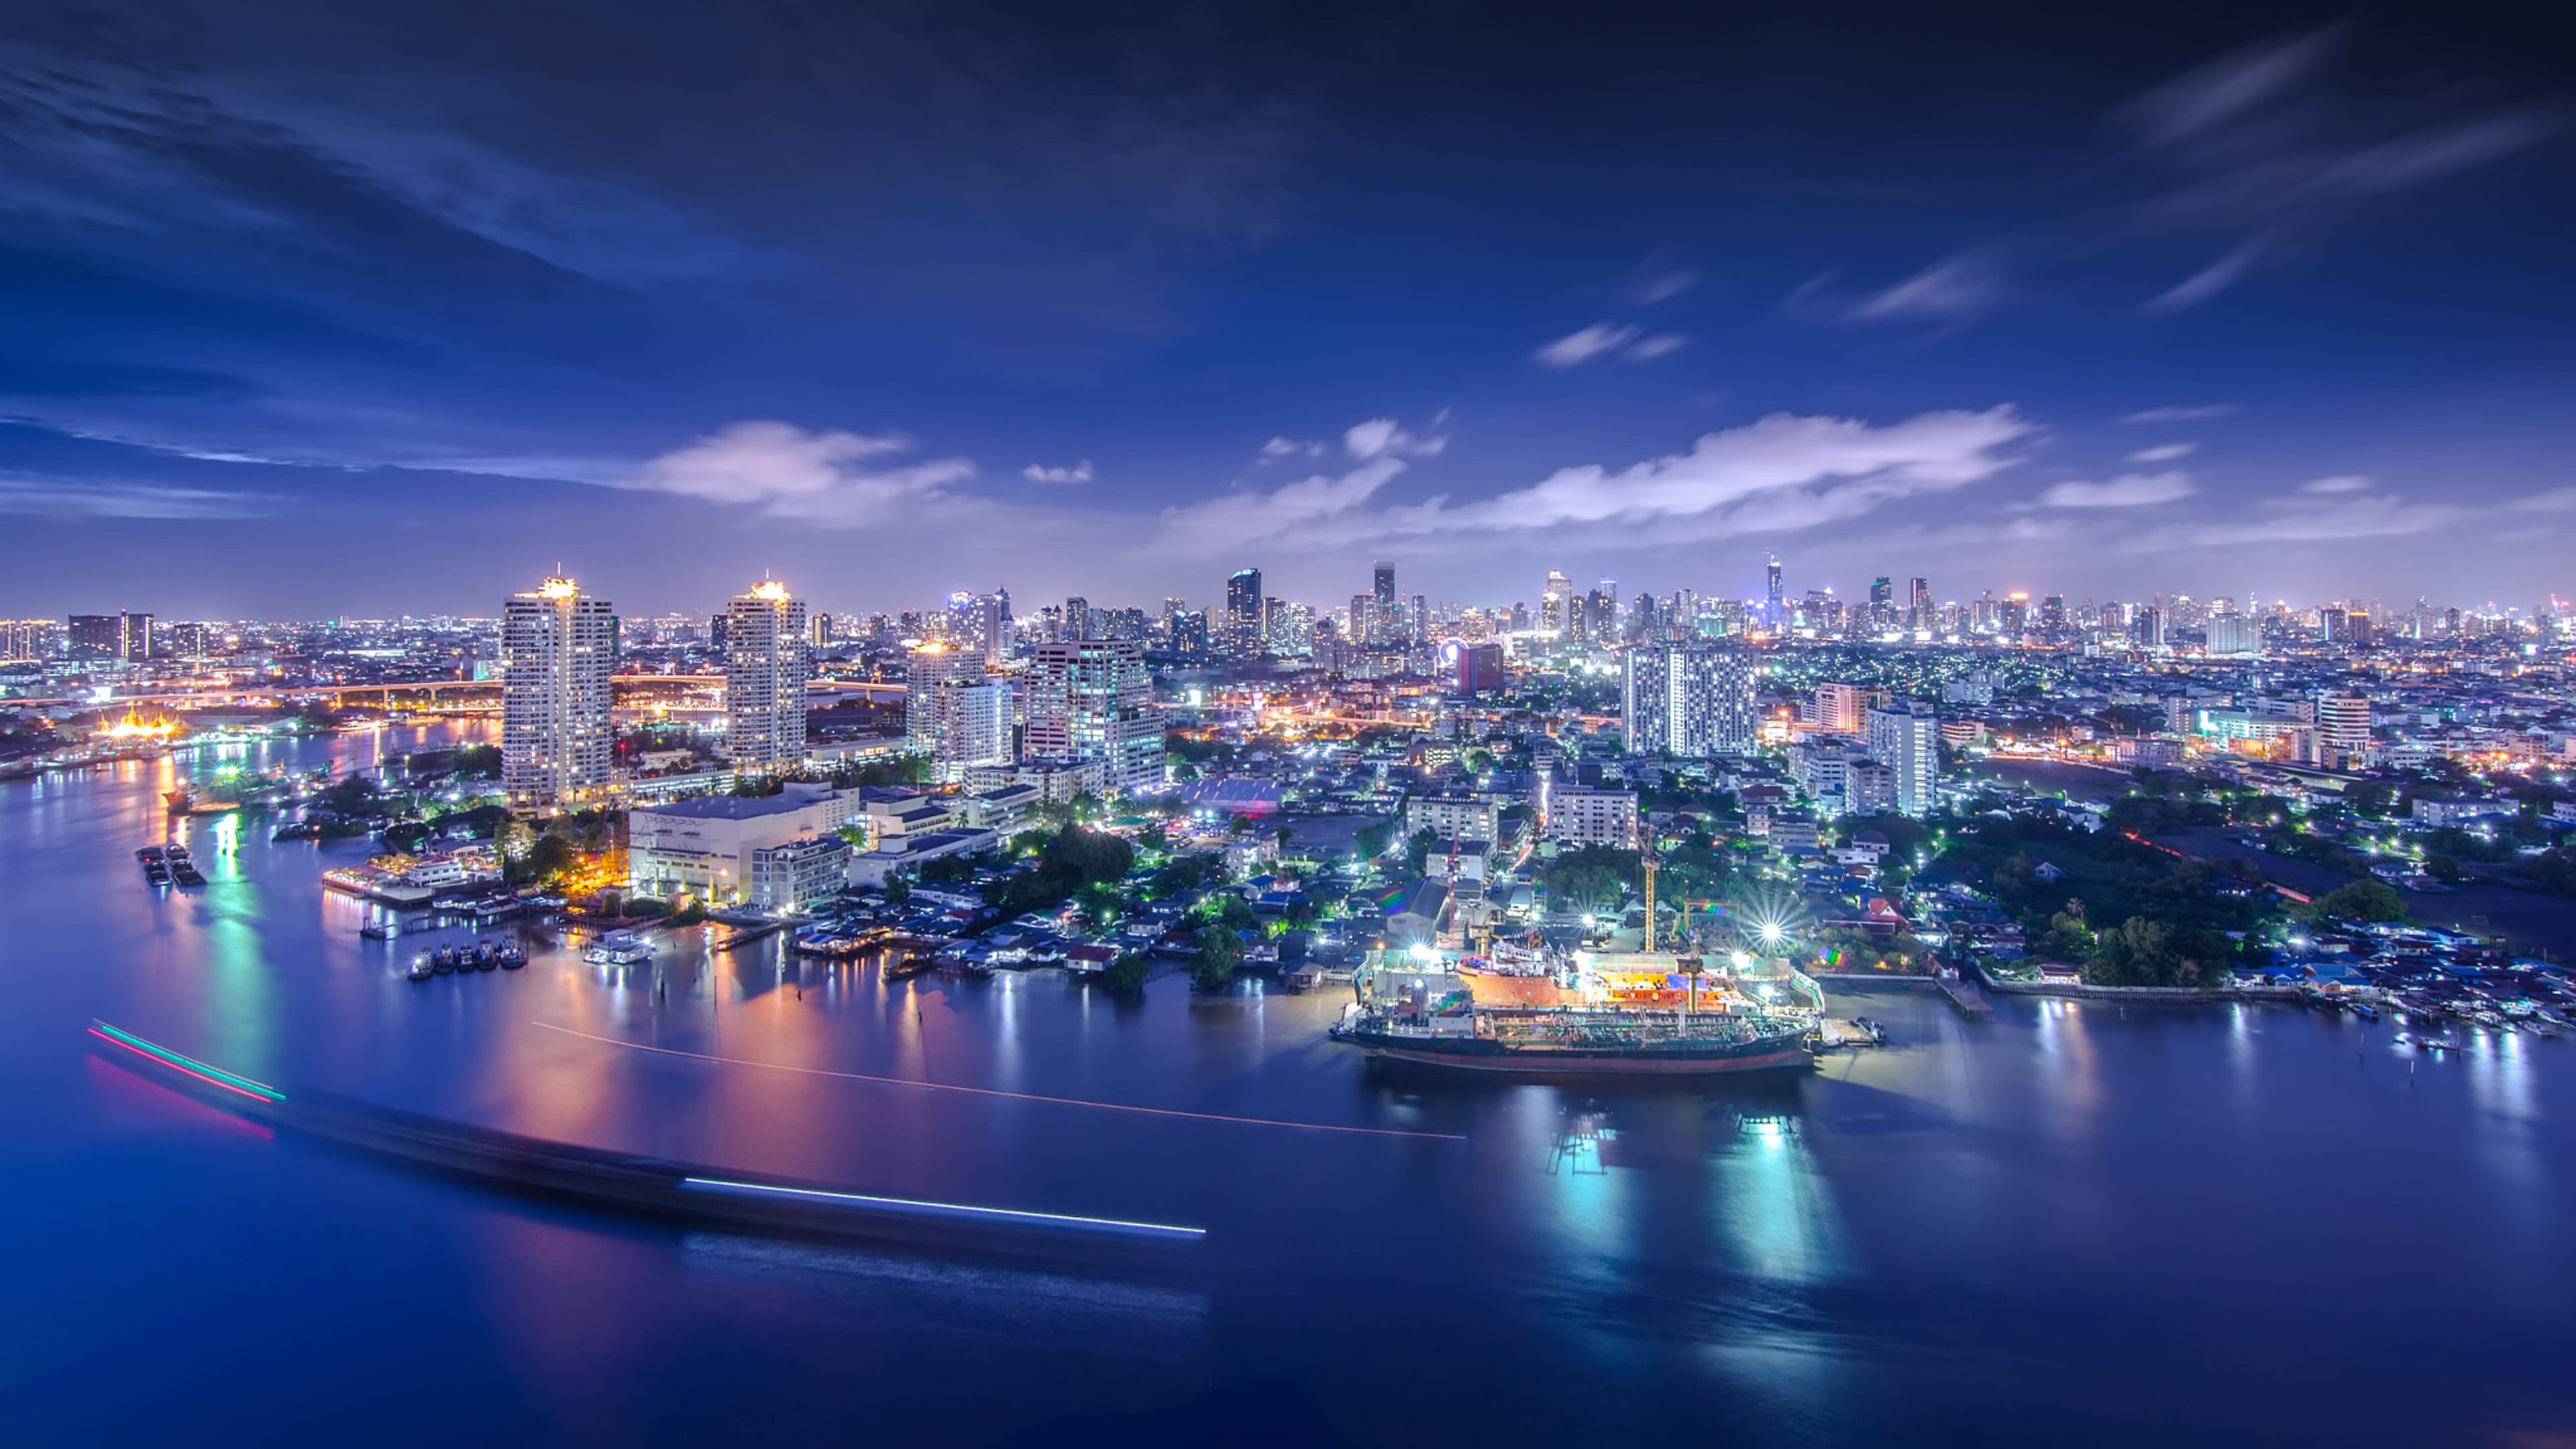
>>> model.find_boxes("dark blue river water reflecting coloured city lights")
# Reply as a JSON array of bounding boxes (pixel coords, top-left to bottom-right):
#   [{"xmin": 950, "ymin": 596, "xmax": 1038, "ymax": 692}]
[{"xmin": 0, "ymin": 730, "xmax": 2576, "ymax": 1444}]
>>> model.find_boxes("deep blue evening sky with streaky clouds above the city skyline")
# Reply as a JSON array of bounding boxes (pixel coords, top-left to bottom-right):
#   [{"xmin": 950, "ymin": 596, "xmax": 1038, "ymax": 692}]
[{"xmin": 0, "ymin": 0, "xmax": 2576, "ymax": 616}]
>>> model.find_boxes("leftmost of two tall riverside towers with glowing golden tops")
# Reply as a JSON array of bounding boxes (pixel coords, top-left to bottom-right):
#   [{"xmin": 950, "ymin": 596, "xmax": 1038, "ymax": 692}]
[{"xmin": 500, "ymin": 578, "xmax": 619, "ymax": 810}]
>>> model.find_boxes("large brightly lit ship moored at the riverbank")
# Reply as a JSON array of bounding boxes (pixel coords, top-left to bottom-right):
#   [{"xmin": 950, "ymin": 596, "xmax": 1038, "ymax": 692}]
[{"xmin": 1329, "ymin": 951, "xmax": 1824, "ymax": 1078}]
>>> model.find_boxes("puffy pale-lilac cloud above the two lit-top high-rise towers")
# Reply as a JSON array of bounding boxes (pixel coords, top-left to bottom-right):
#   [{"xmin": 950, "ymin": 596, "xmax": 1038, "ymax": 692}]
[{"xmin": 621, "ymin": 423, "xmax": 974, "ymax": 526}]
